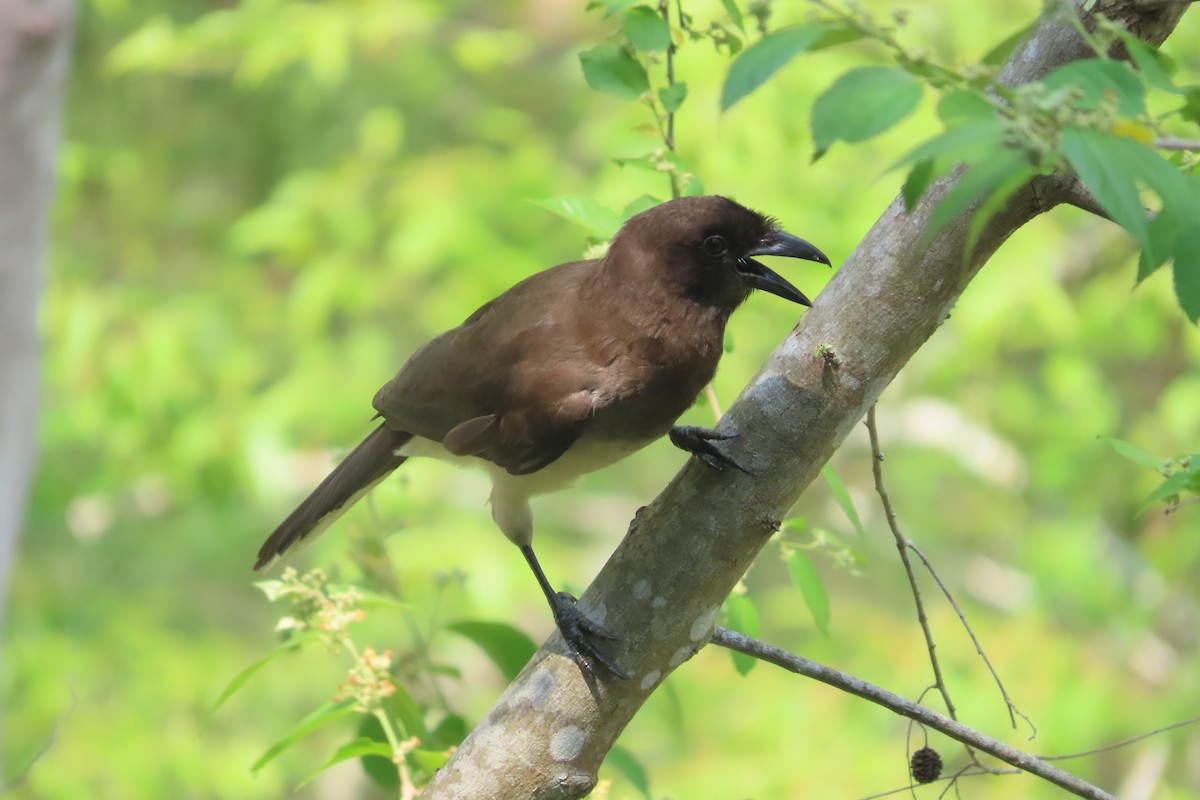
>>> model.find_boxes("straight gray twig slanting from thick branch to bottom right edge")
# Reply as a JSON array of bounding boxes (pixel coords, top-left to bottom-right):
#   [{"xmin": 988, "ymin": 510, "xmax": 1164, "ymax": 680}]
[{"xmin": 710, "ymin": 627, "xmax": 1116, "ymax": 800}]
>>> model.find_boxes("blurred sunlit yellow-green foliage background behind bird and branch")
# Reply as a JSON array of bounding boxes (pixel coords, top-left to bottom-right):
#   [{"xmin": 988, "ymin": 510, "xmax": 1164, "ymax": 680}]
[{"xmin": 0, "ymin": 0, "xmax": 1200, "ymax": 799}]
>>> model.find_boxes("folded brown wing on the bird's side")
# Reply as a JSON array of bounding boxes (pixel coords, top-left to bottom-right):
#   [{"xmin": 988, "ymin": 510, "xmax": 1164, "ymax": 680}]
[{"xmin": 374, "ymin": 261, "xmax": 604, "ymax": 475}]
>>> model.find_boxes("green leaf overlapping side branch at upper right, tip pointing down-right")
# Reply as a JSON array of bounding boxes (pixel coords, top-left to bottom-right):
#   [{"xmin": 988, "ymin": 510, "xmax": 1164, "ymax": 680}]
[{"xmin": 1060, "ymin": 128, "xmax": 1147, "ymax": 247}]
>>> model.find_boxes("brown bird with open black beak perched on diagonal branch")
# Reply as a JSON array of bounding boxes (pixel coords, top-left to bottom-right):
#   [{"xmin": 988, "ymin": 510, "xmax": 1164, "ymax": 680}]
[{"xmin": 254, "ymin": 196, "xmax": 829, "ymax": 678}]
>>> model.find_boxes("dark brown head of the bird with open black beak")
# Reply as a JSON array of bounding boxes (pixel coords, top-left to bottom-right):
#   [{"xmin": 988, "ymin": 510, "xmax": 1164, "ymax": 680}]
[{"xmin": 610, "ymin": 196, "xmax": 829, "ymax": 309}]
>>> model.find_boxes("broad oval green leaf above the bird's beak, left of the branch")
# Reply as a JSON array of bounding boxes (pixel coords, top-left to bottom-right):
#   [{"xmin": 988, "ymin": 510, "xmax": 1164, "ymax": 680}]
[{"xmin": 812, "ymin": 67, "xmax": 922, "ymax": 157}]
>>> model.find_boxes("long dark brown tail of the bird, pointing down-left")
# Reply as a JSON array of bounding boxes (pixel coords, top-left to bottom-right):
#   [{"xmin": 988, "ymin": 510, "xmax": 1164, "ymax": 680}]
[{"xmin": 254, "ymin": 425, "xmax": 413, "ymax": 570}]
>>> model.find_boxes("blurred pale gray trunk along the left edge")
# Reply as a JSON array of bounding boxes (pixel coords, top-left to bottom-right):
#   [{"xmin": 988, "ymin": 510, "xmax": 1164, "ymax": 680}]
[{"xmin": 0, "ymin": 0, "xmax": 72, "ymax": 657}]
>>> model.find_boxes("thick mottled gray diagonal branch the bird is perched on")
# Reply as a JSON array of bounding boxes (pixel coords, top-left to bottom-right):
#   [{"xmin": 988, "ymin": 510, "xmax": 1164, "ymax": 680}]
[{"xmin": 424, "ymin": 0, "xmax": 1186, "ymax": 800}]
